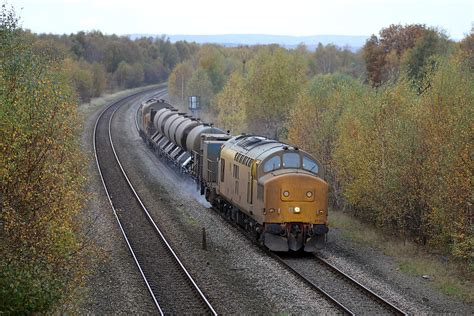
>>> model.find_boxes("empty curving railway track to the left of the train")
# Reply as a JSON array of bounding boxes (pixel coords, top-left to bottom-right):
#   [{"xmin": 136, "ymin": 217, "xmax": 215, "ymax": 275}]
[{"xmin": 93, "ymin": 87, "xmax": 217, "ymax": 315}]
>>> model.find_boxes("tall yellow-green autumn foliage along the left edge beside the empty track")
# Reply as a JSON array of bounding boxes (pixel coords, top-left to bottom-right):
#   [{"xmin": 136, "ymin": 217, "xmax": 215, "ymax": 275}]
[{"xmin": 0, "ymin": 5, "xmax": 89, "ymax": 314}]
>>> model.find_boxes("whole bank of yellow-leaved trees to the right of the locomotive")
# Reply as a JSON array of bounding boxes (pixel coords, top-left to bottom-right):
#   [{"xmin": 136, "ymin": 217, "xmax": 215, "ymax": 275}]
[{"xmin": 287, "ymin": 58, "xmax": 474, "ymax": 259}]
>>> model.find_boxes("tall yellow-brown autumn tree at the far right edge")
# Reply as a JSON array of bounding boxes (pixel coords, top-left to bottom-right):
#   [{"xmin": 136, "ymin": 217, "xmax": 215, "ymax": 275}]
[{"xmin": 417, "ymin": 52, "xmax": 474, "ymax": 256}]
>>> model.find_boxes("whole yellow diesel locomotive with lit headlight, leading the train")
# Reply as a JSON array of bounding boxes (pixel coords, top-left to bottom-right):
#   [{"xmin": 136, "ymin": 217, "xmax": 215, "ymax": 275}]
[{"xmin": 218, "ymin": 135, "xmax": 328, "ymax": 252}]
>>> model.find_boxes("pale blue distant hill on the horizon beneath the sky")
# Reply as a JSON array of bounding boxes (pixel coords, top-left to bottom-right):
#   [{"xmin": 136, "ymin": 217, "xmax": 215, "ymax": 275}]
[{"xmin": 129, "ymin": 34, "xmax": 369, "ymax": 51}]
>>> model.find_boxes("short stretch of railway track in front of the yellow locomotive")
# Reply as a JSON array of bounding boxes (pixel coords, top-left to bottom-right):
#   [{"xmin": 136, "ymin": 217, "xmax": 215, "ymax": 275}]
[{"xmin": 275, "ymin": 254, "xmax": 407, "ymax": 315}]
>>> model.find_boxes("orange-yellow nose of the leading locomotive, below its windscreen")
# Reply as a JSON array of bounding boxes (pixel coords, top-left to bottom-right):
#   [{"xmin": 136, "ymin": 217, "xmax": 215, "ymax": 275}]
[{"xmin": 261, "ymin": 169, "xmax": 328, "ymax": 252}]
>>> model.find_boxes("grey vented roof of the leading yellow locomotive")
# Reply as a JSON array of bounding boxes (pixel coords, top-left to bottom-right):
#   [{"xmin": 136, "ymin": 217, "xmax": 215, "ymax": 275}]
[{"xmin": 224, "ymin": 135, "xmax": 290, "ymax": 160}]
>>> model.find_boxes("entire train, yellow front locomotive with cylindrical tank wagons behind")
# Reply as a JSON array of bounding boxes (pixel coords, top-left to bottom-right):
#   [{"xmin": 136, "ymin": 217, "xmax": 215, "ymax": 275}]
[{"xmin": 137, "ymin": 99, "xmax": 328, "ymax": 252}]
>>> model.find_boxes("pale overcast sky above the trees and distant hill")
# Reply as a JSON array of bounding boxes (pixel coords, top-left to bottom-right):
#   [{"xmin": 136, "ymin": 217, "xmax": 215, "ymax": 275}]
[{"xmin": 7, "ymin": 0, "xmax": 474, "ymax": 39}]
